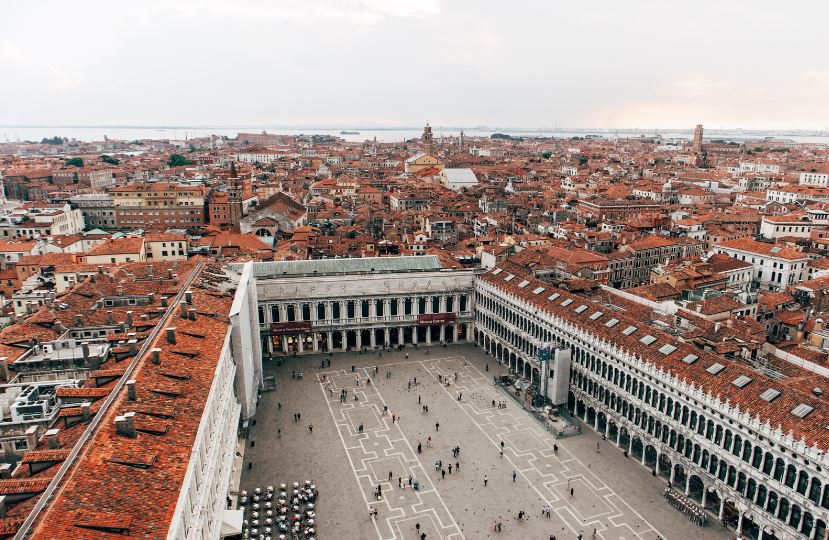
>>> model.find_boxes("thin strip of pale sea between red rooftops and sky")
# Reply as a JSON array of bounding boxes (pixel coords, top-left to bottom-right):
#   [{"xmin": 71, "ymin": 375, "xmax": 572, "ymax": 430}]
[{"xmin": 0, "ymin": 125, "xmax": 829, "ymax": 144}]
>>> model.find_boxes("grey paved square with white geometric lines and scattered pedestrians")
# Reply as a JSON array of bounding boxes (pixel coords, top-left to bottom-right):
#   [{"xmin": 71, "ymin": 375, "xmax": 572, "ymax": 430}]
[{"xmin": 241, "ymin": 345, "xmax": 729, "ymax": 540}]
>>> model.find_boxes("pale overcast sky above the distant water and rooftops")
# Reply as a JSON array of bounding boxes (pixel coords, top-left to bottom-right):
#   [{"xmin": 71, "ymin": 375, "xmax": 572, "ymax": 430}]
[{"xmin": 0, "ymin": 0, "xmax": 829, "ymax": 130}]
